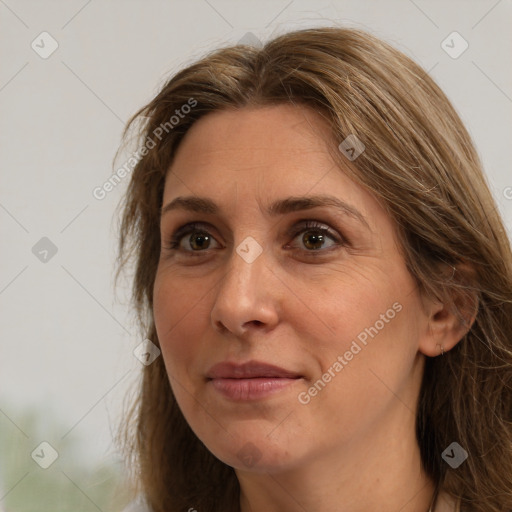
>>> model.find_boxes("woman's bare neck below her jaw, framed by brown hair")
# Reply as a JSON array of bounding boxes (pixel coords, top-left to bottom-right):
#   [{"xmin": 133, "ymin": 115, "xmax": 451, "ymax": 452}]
[{"xmin": 236, "ymin": 400, "xmax": 434, "ymax": 512}]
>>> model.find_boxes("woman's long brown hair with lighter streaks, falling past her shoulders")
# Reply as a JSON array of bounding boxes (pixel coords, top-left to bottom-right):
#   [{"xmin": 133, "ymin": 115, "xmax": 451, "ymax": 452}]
[{"xmin": 118, "ymin": 27, "xmax": 512, "ymax": 512}]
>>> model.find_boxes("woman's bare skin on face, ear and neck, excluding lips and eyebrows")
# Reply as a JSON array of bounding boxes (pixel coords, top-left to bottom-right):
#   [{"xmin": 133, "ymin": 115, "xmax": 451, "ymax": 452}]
[{"xmin": 154, "ymin": 105, "xmax": 463, "ymax": 512}]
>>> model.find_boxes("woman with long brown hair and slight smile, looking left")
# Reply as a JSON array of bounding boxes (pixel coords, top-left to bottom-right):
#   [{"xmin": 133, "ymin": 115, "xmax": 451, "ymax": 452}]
[{"xmin": 116, "ymin": 28, "xmax": 512, "ymax": 512}]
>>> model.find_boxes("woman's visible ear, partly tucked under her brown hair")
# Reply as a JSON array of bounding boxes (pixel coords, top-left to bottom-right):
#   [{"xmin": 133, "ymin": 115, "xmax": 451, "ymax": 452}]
[{"xmin": 419, "ymin": 263, "xmax": 478, "ymax": 357}]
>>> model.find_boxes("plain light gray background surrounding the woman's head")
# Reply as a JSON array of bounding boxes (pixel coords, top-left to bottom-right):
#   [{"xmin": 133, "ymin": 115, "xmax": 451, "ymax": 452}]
[{"xmin": 0, "ymin": 0, "xmax": 512, "ymax": 510}]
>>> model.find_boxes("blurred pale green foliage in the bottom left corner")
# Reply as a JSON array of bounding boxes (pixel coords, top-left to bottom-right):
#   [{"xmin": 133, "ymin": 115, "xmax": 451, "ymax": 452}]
[{"xmin": 0, "ymin": 405, "xmax": 130, "ymax": 512}]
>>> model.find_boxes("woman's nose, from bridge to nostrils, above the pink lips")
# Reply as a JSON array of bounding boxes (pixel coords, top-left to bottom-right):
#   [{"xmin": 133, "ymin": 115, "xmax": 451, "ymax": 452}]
[{"xmin": 211, "ymin": 245, "xmax": 282, "ymax": 337}]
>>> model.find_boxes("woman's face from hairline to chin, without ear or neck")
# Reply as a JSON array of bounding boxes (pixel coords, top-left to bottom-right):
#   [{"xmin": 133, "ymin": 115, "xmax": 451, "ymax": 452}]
[{"xmin": 154, "ymin": 105, "xmax": 428, "ymax": 472}]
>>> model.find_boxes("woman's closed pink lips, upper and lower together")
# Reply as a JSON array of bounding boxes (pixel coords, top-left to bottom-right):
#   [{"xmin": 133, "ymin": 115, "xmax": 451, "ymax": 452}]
[{"xmin": 206, "ymin": 361, "xmax": 301, "ymax": 401}]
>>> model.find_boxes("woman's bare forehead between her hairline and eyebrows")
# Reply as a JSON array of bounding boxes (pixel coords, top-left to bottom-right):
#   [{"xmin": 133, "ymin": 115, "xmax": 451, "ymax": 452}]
[{"xmin": 164, "ymin": 105, "xmax": 383, "ymax": 230}]
